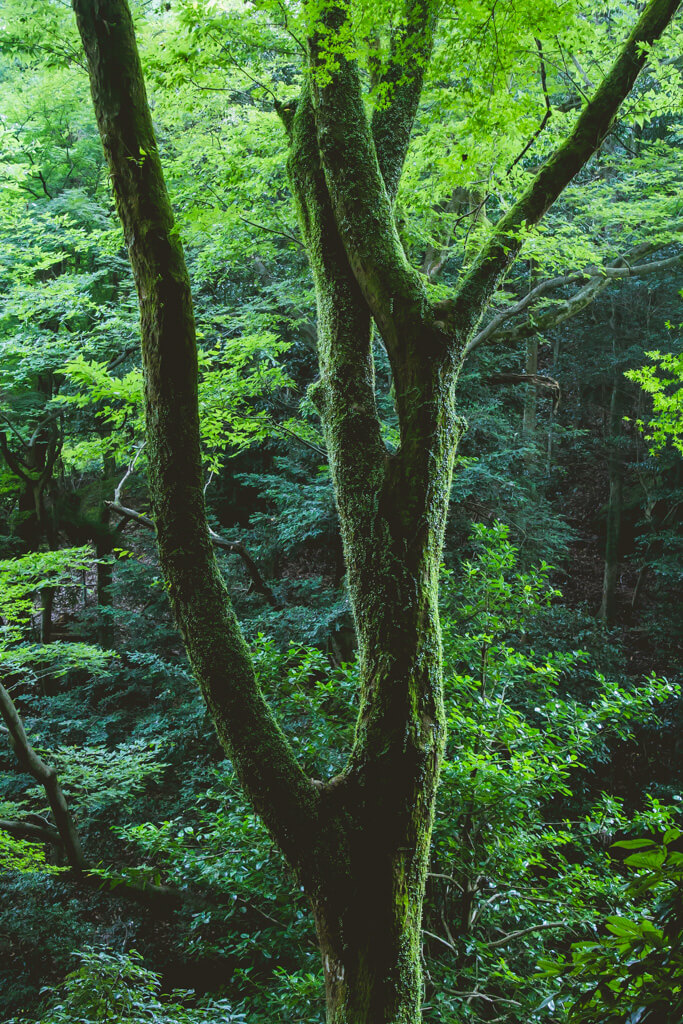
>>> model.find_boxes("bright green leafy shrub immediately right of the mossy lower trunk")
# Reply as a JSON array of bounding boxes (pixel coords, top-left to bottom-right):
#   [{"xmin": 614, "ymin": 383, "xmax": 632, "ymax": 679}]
[{"xmin": 425, "ymin": 524, "xmax": 676, "ymax": 1024}]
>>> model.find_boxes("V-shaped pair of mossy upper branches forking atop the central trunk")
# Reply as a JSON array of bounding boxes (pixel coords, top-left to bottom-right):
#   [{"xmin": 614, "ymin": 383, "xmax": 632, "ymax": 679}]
[{"xmin": 309, "ymin": 0, "xmax": 681, "ymax": 369}]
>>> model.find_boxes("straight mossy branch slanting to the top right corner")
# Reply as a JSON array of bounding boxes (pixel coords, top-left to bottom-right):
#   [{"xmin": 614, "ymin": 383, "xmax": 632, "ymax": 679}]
[{"xmin": 450, "ymin": 0, "xmax": 681, "ymax": 335}]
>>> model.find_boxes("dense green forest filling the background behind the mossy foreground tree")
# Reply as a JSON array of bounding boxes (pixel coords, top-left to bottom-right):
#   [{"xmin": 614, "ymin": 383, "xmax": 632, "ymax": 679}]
[{"xmin": 0, "ymin": 0, "xmax": 683, "ymax": 1024}]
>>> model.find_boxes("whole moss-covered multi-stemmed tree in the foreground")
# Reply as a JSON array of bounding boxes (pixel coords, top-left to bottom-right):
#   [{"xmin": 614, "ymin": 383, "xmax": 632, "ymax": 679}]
[{"xmin": 68, "ymin": 0, "xmax": 679, "ymax": 1024}]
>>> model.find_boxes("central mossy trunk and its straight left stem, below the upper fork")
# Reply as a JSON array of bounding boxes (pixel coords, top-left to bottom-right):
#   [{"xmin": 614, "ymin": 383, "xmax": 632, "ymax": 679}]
[{"xmin": 290, "ymin": 83, "xmax": 460, "ymax": 1024}]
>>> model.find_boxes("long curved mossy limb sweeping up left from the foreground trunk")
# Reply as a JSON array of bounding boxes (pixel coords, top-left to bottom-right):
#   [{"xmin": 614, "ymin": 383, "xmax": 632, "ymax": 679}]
[{"xmin": 73, "ymin": 0, "xmax": 318, "ymax": 868}]
